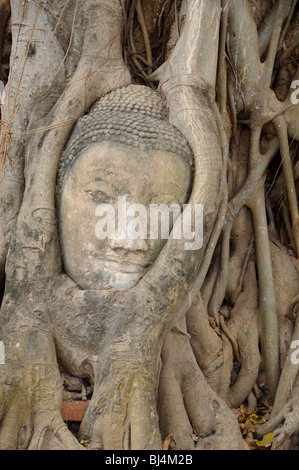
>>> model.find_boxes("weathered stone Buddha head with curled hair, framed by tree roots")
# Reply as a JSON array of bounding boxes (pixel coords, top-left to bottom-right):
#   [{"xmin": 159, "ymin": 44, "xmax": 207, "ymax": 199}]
[{"xmin": 57, "ymin": 85, "xmax": 192, "ymax": 290}]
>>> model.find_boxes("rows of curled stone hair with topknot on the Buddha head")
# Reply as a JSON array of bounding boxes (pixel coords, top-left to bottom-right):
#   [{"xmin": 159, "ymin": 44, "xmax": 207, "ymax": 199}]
[{"xmin": 57, "ymin": 85, "xmax": 192, "ymax": 190}]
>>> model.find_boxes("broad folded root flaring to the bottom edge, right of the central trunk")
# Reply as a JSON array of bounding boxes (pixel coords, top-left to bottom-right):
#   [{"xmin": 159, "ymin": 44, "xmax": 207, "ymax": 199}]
[{"xmin": 159, "ymin": 318, "xmax": 244, "ymax": 450}]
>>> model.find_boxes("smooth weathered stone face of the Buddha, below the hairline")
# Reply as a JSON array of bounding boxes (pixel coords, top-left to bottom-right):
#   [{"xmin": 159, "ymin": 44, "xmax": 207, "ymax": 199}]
[{"xmin": 59, "ymin": 142, "xmax": 192, "ymax": 290}]
